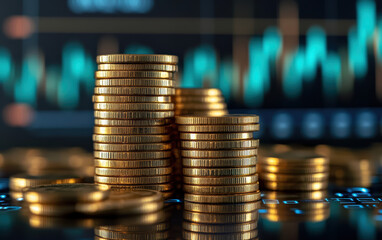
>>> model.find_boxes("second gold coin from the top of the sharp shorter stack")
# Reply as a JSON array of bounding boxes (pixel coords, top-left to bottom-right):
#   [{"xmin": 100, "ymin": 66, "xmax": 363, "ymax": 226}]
[{"xmin": 178, "ymin": 123, "xmax": 260, "ymax": 133}]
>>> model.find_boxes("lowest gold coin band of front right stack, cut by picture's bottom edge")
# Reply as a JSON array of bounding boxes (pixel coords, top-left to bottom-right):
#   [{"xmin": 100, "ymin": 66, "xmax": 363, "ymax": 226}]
[{"xmin": 182, "ymin": 230, "xmax": 258, "ymax": 240}]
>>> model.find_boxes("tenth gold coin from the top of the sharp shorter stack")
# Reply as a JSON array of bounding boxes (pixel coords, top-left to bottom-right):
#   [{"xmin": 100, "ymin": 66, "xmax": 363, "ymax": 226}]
[{"xmin": 184, "ymin": 191, "xmax": 261, "ymax": 203}]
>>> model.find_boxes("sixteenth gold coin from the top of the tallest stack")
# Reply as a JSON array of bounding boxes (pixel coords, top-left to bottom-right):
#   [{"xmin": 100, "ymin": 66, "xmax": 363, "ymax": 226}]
[{"xmin": 94, "ymin": 175, "xmax": 172, "ymax": 185}]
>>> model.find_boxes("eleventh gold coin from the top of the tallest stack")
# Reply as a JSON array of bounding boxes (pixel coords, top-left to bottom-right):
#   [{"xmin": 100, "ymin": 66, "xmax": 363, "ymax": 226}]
[{"xmin": 93, "ymin": 134, "xmax": 170, "ymax": 143}]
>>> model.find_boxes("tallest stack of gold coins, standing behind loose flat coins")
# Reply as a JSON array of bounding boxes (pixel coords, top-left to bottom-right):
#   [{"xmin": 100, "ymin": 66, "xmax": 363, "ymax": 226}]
[{"xmin": 93, "ymin": 54, "xmax": 178, "ymax": 197}]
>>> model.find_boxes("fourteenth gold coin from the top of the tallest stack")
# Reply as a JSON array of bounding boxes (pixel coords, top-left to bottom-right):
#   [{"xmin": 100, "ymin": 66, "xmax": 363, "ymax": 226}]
[{"xmin": 94, "ymin": 158, "xmax": 172, "ymax": 168}]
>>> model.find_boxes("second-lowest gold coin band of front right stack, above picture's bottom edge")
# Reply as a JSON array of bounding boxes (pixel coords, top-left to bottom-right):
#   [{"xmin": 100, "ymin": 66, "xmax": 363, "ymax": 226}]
[{"xmin": 183, "ymin": 221, "xmax": 257, "ymax": 234}]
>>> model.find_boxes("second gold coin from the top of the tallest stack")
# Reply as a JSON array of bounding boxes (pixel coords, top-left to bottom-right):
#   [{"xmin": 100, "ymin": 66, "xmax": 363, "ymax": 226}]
[{"xmin": 98, "ymin": 63, "xmax": 178, "ymax": 72}]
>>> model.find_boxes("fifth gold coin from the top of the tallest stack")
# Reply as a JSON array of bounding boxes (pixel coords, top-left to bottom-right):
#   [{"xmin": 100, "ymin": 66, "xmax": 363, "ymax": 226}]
[{"xmin": 94, "ymin": 87, "xmax": 175, "ymax": 96}]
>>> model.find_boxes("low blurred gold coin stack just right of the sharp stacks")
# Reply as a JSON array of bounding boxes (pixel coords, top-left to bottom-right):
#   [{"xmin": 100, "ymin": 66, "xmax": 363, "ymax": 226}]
[{"xmin": 259, "ymin": 150, "xmax": 329, "ymax": 191}]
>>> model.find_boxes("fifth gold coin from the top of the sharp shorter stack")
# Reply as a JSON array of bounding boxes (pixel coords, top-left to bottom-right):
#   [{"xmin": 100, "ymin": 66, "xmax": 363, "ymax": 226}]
[{"xmin": 180, "ymin": 148, "xmax": 257, "ymax": 158}]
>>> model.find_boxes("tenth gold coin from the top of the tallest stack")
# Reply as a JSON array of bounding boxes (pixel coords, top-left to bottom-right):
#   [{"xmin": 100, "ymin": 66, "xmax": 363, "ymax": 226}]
[{"xmin": 94, "ymin": 126, "xmax": 172, "ymax": 135}]
